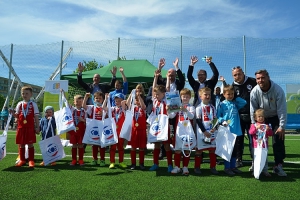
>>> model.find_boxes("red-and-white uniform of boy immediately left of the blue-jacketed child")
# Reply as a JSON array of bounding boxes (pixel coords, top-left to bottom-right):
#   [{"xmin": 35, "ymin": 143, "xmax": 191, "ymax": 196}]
[{"xmin": 195, "ymin": 102, "xmax": 217, "ymax": 174}]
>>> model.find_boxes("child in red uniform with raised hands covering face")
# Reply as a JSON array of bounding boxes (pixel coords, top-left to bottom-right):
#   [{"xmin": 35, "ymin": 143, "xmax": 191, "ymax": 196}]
[{"xmin": 127, "ymin": 90, "xmax": 147, "ymax": 170}]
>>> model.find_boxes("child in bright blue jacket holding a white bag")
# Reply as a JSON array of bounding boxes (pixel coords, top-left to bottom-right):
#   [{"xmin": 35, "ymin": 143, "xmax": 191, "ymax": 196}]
[{"xmin": 217, "ymin": 85, "xmax": 247, "ymax": 176}]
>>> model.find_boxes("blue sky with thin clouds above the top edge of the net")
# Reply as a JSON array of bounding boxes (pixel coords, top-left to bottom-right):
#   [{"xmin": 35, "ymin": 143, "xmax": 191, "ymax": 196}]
[{"xmin": 0, "ymin": 0, "xmax": 300, "ymax": 46}]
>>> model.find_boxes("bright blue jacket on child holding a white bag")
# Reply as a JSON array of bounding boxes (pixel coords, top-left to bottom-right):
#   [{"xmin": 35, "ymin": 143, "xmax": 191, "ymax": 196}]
[{"xmin": 217, "ymin": 97, "xmax": 247, "ymax": 136}]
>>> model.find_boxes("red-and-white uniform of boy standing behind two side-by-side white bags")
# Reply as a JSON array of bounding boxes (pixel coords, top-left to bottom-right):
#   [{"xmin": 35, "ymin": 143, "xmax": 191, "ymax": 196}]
[{"xmin": 86, "ymin": 105, "xmax": 105, "ymax": 166}]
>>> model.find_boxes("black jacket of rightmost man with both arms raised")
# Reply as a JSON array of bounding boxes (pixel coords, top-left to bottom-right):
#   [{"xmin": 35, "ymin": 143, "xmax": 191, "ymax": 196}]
[{"xmin": 187, "ymin": 62, "xmax": 219, "ymax": 106}]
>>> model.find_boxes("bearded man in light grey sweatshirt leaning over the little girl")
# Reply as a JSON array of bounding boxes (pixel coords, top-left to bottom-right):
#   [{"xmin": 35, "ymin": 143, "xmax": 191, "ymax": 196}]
[{"xmin": 250, "ymin": 69, "xmax": 287, "ymax": 176}]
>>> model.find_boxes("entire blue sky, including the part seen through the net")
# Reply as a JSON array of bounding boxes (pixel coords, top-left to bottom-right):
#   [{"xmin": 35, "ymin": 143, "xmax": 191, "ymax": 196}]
[{"xmin": 0, "ymin": 0, "xmax": 300, "ymax": 91}]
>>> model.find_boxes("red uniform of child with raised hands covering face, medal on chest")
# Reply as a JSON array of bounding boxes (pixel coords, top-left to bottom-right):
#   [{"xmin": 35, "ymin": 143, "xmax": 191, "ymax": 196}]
[{"xmin": 129, "ymin": 106, "xmax": 147, "ymax": 166}]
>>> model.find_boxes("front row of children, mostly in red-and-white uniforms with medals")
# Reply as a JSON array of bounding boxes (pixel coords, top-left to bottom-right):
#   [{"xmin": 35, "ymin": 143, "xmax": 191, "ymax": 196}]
[{"xmin": 14, "ymin": 75, "xmax": 272, "ymax": 176}]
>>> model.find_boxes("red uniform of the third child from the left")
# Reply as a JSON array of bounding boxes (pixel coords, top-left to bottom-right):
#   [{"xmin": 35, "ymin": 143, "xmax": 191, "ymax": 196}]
[{"xmin": 68, "ymin": 107, "xmax": 86, "ymax": 164}]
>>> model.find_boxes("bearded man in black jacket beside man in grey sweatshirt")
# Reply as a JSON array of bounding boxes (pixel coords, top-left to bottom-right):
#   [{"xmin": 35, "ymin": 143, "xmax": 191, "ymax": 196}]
[{"xmin": 224, "ymin": 66, "xmax": 256, "ymax": 170}]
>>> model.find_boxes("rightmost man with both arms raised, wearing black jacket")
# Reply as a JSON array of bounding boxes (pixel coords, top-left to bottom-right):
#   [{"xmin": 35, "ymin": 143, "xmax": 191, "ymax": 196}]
[{"xmin": 187, "ymin": 56, "xmax": 219, "ymax": 107}]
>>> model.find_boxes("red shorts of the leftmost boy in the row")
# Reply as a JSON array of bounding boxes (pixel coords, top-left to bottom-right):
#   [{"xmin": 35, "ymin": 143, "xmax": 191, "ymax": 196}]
[{"xmin": 16, "ymin": 127, "xmax": 36, "ymax": 145}]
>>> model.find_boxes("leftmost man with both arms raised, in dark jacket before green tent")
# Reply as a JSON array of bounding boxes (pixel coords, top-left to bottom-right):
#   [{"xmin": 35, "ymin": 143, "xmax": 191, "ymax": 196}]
[{"xmin": 77, "ymin": 62, "xmax": 117, "ymax": 105}]
